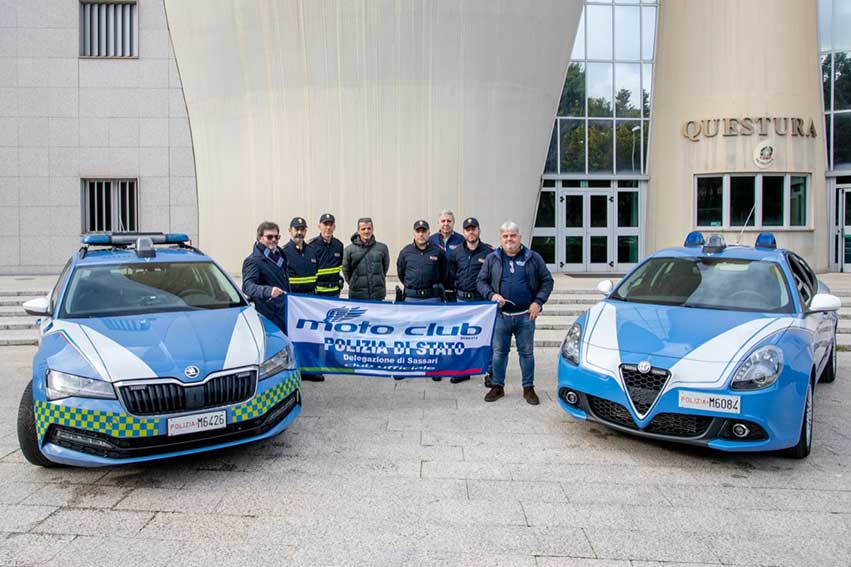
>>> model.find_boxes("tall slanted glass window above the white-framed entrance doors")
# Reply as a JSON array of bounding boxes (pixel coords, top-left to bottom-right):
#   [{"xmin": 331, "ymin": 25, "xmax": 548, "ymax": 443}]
[{"xmin": 544, "ymin": 0, "xmax": 657, "ymax": 175}]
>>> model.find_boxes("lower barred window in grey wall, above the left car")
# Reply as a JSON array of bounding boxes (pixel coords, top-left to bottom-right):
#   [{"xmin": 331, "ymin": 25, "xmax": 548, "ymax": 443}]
[{"xmin": 82, "ymin": 179, "xmax": 139, "ymax": 233}]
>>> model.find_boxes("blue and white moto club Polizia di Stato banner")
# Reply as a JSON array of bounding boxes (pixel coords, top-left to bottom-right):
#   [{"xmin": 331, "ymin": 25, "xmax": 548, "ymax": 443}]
[{"xmin": 287, "ymin": 294, "xmax": 497, "ymax": 376}]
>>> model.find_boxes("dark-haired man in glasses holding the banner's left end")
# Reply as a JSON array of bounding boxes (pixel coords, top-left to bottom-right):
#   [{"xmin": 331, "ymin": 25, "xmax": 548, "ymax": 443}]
[{"xmin": 242, "ymin": 221, "xmax": 290, "ymax": 332}]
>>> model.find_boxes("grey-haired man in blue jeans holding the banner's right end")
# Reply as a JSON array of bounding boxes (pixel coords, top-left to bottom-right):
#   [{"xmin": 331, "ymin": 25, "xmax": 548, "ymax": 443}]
[{"xmin": 477, "ymin": 221, "xmax": 554, "ymax": 406}]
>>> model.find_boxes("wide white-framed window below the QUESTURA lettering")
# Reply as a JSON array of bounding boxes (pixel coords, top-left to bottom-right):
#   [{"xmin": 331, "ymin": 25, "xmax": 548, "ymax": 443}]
[{"xmin": 694, "ymin": 173, "xmax": 809, "ymax": 230}]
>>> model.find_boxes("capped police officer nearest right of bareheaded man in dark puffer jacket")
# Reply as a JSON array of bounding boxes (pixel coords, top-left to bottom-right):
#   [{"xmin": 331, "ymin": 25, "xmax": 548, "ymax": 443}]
[{"xmin": 395, "ymin": 220, "xmax": 448, "ymax": 382}]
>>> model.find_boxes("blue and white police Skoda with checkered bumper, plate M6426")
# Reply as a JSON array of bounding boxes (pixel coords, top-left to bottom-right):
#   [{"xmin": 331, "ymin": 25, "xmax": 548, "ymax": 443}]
[{"xmin": 18, "ymin": 233, "xmax": 301, "ymax": 466}]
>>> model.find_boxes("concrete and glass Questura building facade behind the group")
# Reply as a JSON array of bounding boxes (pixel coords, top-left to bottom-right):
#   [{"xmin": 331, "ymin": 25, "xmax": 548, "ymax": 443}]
[{"xmin": 0, "ymin": 0, "xmax": 851, "ymax": 273}]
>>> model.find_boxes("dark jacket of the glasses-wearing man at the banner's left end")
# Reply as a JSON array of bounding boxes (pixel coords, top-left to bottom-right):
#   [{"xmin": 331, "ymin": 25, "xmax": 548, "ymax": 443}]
[{"xmin": 242, "ymin": 243, "xmax": 290, "ymax": 331}]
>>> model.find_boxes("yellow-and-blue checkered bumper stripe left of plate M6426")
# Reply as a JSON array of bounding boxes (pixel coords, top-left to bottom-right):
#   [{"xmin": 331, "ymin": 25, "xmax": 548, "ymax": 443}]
[{"xmin": 35, "ymin": 400, "xmax": 162, "ymax": 441}]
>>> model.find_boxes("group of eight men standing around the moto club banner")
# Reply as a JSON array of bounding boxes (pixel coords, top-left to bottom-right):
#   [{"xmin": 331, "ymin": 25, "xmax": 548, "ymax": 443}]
[{"xmin": 242, "ymin": 210, "xmax": 553, "ymax": 405}]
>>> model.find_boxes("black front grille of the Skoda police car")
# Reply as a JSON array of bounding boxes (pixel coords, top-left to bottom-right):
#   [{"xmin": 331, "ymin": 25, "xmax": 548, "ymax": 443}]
[{"xmin": 118, "ymin": 370, "xmax": 257, "ymax": 415}]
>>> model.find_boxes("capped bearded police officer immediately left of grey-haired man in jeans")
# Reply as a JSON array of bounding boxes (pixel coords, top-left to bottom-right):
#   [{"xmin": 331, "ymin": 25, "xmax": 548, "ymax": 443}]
[{"xmin": 447, "ymin": 217, "xmax": 494, "ymax": 388}]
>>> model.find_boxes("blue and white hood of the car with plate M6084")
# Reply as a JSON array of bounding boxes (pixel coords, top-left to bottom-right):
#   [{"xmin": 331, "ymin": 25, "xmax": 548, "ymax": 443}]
[{"xmin": 581, "ymin": 300, "xmax": 797, "ymax": 386}]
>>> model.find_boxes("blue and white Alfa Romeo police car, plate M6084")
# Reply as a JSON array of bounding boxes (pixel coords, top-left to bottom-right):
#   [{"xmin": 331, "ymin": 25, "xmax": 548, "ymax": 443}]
[{"xmin": 558, "ymin": 232, "xmax": 840, "ymax": 458}]
